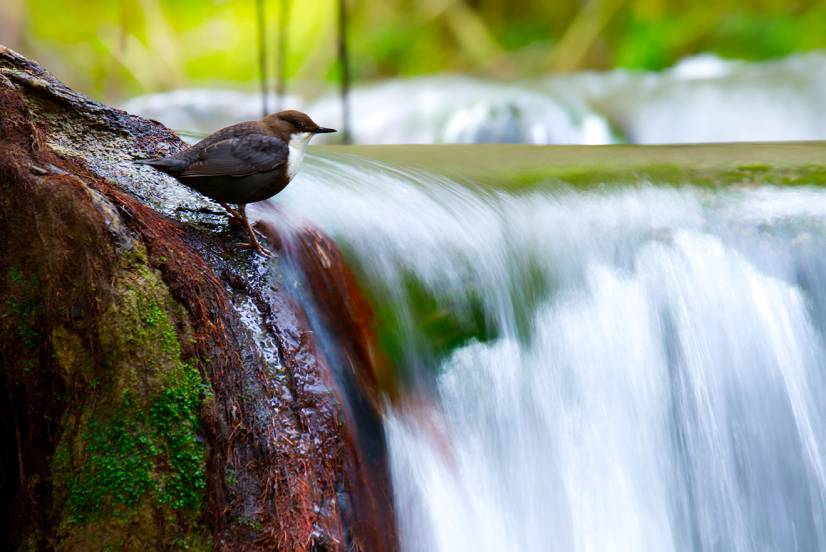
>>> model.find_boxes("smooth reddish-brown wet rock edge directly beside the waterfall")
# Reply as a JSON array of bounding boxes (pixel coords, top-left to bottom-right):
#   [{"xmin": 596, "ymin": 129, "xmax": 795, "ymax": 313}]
[{"xmin": 258, "ymin": 223, "xmax": 397, "ymax": 550}]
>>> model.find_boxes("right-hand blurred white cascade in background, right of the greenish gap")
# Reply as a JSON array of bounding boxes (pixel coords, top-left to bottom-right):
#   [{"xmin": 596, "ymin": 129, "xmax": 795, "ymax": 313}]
[{"xmin": 546, "ymin": 53, "xmax": 826, "ymax": 144}]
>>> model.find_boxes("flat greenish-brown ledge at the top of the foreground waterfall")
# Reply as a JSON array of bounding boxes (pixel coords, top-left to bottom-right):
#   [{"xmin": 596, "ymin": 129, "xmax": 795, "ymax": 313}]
[{"xmin": 308, "ymin": 142, "xmax": 826, "ymax": 192}]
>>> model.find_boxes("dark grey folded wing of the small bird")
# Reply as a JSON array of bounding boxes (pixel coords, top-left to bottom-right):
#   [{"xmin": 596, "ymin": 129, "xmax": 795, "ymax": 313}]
[{"xmin": 178, "ymin": 134, "xmax": 289, "ymax": 178}]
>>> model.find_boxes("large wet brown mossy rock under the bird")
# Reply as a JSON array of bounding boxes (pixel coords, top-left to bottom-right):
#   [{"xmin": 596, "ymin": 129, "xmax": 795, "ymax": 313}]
[{"xmin": 0, "ymin": 47, "xmax": 396, "ymax": 550}]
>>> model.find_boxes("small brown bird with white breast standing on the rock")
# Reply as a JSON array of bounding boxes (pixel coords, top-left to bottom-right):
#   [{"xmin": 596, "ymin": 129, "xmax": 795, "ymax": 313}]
[{"xmin": 135, "ymin": 109, "xmax": 336, "ymax": 257}]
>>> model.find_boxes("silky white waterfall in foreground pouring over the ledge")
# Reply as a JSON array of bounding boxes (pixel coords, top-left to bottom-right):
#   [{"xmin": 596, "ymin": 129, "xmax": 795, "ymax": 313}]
[{"xmin": 268, "ymin": 160, "xmax": 826, "ymax": 552}]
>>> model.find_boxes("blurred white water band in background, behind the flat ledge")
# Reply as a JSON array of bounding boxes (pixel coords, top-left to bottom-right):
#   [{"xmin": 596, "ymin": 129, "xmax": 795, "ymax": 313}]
[{"xmin": 125, "ymin": 53, "xmax": 826, "ymax": 144}]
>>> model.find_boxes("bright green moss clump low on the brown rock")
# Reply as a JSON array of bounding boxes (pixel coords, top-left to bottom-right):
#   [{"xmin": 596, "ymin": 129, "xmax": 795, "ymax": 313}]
[{"xmin": 68, "ymin": 364, "xmax": 206, "ymax": 523}]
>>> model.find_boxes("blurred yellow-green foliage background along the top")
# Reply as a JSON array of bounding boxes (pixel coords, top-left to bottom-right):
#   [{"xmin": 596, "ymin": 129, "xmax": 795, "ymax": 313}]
[{"xmin": 0, "ymin": 0, "xmax": 826, "ymax": 101}]
